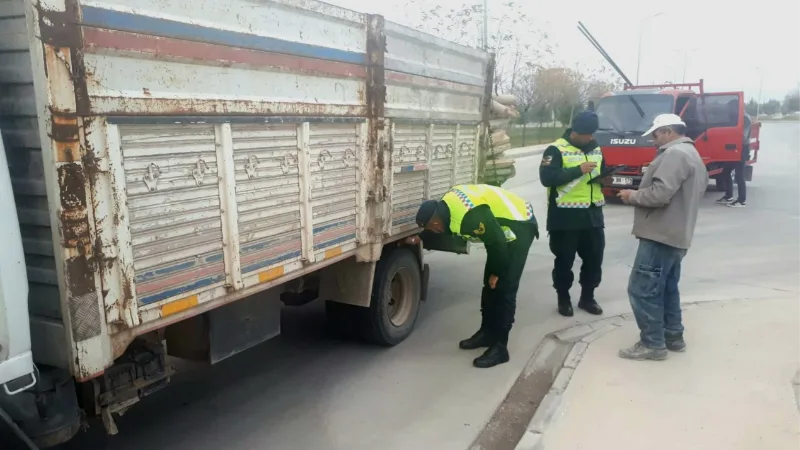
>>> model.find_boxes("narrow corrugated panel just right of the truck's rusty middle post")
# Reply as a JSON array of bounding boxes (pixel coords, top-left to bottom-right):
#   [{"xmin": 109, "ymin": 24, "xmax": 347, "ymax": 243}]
[{"xmin": 392, "ymin": 124, "xmax": 428, "ymax": 233}]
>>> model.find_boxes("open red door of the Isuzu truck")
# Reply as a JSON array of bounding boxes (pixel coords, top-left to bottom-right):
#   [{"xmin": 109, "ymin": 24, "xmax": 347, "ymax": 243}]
[{"xmin": 684, "ymin": 92, "xmax": 744, "ymax": 170}]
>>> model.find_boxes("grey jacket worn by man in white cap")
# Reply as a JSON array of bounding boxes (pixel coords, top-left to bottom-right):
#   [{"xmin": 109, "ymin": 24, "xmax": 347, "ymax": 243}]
[{"xmin": 630, "ymin": 137, "xmax": 708, "ymax": 249}]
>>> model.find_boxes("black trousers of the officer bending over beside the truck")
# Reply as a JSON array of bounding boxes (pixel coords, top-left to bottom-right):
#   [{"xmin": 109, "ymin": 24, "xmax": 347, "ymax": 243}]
[{"xmin": 481, "ymin": 230, "xmax": 534, "ymax": 344}]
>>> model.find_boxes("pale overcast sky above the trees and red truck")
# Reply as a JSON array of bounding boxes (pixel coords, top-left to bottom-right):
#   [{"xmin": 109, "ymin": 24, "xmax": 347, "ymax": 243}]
[{"xmin": 329, "ymin": 0, "xmax": 800, "ymax": 101}]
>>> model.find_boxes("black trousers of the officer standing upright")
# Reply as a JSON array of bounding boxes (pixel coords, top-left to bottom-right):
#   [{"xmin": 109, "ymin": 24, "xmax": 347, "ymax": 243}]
[{"xmin": 550, "ymin": 228, "xmax": 606, "ymax": 294}]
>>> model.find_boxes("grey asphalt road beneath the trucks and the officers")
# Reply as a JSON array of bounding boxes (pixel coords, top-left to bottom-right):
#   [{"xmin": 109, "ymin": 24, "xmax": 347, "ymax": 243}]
[{"xmin": 53, "ymin": 123, "xmax": 800, "ymax": 450}]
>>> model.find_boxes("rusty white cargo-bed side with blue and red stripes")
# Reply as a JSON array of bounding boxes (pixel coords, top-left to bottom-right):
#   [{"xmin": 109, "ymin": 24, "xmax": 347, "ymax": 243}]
[{"xmin": 16, "ymin": 0, "xmax": 488, "ymax": 379}]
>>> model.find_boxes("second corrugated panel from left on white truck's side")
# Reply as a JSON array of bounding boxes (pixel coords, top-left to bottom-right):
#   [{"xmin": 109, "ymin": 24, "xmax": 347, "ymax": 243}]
[{"xmin": 232, "ymin": 124, "xmax": 301, "ymax": 273}]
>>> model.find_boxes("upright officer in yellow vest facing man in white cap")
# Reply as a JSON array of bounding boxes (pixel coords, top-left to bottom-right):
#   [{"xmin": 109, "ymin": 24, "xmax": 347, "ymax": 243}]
[{"xmin": 539, "ymin": 111, "xmax": 605, "ymax": 317}]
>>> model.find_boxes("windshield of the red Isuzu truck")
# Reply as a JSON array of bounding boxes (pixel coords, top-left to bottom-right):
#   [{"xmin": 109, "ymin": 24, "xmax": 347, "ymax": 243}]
[{"xmin": 595, "ymin": 94, "xmax": 674, "ymax": 133}]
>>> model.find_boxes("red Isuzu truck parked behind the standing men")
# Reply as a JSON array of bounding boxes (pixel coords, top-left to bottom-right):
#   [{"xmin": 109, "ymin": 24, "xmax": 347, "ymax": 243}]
[{"xmin": 595, "ymin": 80, "xmax": 761, "ymax": 197}]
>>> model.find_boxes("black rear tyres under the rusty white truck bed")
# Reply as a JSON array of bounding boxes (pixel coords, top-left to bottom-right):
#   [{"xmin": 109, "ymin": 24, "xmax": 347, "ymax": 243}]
[{"xmin": 326, "ymin": 248, "xmax": 422, "ymax": 346}]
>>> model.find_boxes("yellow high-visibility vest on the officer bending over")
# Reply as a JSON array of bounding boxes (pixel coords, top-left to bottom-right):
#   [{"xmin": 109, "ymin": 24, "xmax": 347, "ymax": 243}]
[{"xmin": 442, "ymin": 184, "xmax": 533, "ymax": 241}]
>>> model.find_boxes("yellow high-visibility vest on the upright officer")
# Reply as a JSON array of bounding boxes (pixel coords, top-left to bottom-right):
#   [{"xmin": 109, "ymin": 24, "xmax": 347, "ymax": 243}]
[{"xmin": 547, "ymin": 138, "xmax": 606, "ymax": 208}]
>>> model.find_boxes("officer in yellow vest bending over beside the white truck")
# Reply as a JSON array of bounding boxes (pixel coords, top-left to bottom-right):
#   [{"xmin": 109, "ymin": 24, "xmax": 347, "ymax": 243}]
[{"xmin": 417, "ymin": 184, "xmax": 539, "ymax": 368}]
